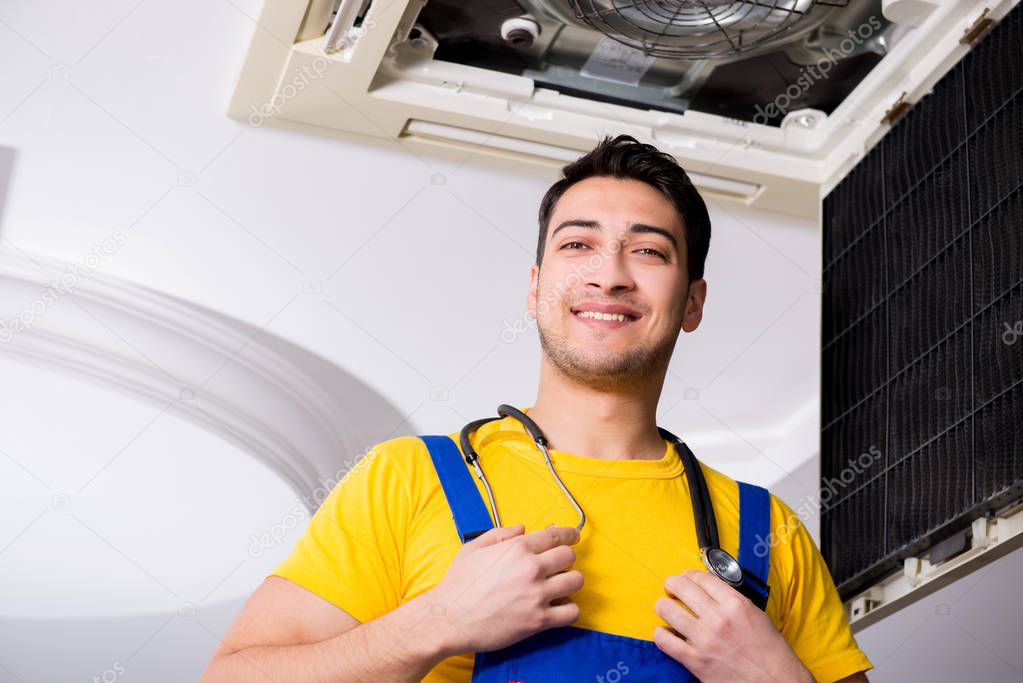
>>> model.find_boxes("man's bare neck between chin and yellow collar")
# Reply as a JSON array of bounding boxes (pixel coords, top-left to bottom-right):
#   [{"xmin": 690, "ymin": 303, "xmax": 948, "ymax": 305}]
[{"xmin": 529, "ymin": 357, "xmax": 667, "ymax": 460}]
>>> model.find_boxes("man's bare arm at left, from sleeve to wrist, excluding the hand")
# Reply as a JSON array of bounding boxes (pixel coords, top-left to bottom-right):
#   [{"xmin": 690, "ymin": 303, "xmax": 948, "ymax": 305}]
[{"xmin": 202, "ymin": 577, "xmax": 453, "ymax": 683}]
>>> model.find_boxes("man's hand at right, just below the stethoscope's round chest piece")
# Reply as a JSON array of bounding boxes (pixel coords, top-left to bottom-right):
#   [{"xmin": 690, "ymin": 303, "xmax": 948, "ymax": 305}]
[{"xmin": 654, "ymin": 570, "xmax": 814, "ymax": 683}]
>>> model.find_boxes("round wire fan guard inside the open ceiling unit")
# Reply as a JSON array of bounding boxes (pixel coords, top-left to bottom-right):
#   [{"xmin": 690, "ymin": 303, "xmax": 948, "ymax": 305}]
[{"xmin": 571, "ymin": 0, "xmax": 848, "ymax": 59}]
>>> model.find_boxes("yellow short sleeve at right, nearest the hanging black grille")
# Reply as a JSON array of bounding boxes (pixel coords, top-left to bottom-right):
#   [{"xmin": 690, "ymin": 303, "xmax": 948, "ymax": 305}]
[{"xmin": 771, "ymin": 496, "xmax": 874, "ymax": 683}]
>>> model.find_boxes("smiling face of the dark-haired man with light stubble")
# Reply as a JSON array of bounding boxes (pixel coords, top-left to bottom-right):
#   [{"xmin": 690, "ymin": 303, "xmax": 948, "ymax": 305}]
[{"xmin": 528, "ymin": 176, "xmax": 706, "ymax": 390}]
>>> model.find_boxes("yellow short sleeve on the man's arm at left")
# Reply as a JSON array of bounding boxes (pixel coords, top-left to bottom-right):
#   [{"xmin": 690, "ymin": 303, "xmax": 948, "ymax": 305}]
[{"xmin": 268, "ymin": 440, "xmax": 410, "ymax": 623}]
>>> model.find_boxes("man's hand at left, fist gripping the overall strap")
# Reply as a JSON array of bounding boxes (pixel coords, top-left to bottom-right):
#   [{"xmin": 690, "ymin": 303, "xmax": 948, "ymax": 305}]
[{"xmin": 424, "ymin": 525, "xmax": 582, "ymax": 653}]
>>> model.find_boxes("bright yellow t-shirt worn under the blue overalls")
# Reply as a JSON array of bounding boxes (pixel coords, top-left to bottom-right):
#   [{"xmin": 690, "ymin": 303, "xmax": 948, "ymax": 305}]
[{"xmin": 271, "ymin": 409, "xmax": 873, "ymax": 683}]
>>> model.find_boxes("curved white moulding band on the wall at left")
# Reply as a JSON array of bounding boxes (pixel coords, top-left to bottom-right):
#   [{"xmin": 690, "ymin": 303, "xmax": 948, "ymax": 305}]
[{"xmin": 0, "ymin": 245, "xmax": 402, "ymax": 509}]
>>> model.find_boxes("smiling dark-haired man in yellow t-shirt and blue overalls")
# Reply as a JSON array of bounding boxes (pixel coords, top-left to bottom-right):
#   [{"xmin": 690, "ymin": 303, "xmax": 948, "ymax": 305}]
[{"xmin": 204, "ymin": 136, "xmax": 872, "ymax": 683}]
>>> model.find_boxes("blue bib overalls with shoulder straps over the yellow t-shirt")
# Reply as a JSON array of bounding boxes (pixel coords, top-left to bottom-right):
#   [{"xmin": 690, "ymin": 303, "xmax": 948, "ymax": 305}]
[{"xmin": 419, "ymin": 436, "xmax": 770, "ymax": 683}]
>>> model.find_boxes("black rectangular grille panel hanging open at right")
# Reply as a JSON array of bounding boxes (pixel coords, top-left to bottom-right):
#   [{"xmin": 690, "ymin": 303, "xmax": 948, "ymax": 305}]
[{"xmin": 820, "ymin": 6, "xmax": 1023, "ymax": 598}]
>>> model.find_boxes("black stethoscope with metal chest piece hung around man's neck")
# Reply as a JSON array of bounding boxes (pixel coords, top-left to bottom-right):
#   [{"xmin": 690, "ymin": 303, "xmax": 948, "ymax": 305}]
[{"xmin": 458, "ymin": 404, "xmax": 757, "ymax": 592}]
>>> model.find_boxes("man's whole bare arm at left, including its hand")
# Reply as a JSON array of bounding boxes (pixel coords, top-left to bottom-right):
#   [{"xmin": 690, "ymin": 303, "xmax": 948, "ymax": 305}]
[{"xmin": 202, "ymin": 525, "xmax": 582, "ymax": 683}]
